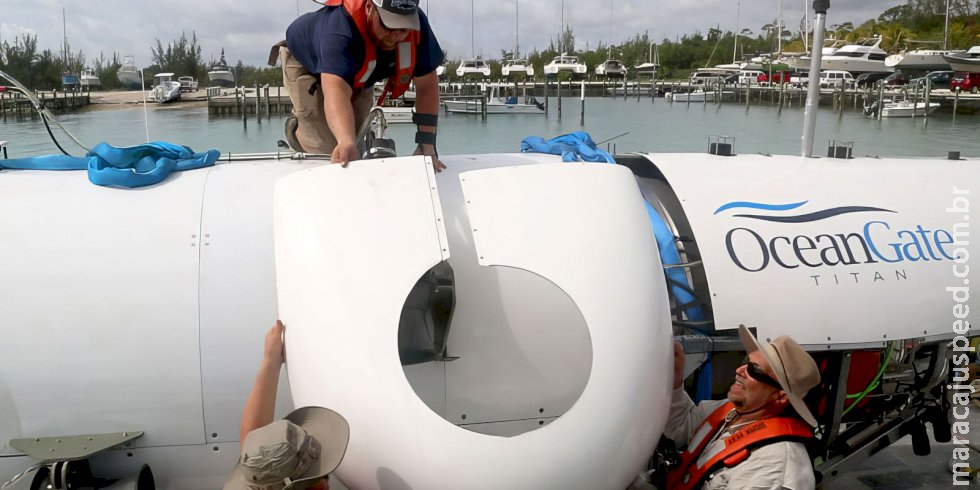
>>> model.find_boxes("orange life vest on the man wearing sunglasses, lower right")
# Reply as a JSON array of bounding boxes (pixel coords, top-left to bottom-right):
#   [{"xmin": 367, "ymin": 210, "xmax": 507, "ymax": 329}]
[{"xmin": 667, "ymin": 402, "xmax": 813, "ymax": 490}]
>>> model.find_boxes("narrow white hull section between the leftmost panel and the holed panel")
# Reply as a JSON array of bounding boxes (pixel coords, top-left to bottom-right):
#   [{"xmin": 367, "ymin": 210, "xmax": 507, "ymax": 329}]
[{"xmin": 193, "ymin": 164, "xmax": 311, "ymax": 443}]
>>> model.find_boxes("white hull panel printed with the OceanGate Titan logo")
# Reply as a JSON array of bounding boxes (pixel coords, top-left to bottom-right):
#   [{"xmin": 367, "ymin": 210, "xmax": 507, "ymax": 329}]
[{"xmin": 647, "ymin": 154, "xmax": 980, "ymax": 348}]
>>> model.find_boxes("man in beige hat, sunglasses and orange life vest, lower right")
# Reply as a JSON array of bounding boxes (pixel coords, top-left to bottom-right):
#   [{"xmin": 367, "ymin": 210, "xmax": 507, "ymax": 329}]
[{"xmin": 664, "ymin": 326, "xmax": 820, "ymax": 490}]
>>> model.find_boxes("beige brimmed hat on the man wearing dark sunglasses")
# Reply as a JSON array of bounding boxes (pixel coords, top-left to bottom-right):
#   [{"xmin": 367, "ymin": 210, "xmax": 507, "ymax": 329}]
[{"xmin": 738, "ymin": 325, "xmax": 820, "ymax": 427}]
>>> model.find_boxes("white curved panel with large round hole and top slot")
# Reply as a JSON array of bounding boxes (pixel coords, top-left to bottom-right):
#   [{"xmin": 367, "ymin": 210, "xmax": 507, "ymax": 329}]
[{"xmin": 274, "ymin": 157, "xmax": 672, "ymax": 489}]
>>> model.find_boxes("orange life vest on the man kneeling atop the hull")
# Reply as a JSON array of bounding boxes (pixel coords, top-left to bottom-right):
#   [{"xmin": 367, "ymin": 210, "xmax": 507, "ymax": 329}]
[{"xmin": 324, "ymin": 0, "xmax": 422, "ymax": 105}]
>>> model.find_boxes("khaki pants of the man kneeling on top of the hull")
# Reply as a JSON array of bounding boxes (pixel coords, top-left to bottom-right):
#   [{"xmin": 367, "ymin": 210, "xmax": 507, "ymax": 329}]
[{"xmin": 279, "ymin": 45, "xmax": 374, "ymax": 155}]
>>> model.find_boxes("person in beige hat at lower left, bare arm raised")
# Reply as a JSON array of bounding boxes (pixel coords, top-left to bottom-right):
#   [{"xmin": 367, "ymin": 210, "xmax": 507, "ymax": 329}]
[{"xmin": 224, "ymin": 321, "xmax": 350, "ymax": 490}]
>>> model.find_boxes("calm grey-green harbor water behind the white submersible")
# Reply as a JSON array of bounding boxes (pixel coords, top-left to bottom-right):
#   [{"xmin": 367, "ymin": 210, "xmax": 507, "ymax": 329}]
[{"xmin": 0, "ymin": 98, "xmax": 980, "ymax": 158}]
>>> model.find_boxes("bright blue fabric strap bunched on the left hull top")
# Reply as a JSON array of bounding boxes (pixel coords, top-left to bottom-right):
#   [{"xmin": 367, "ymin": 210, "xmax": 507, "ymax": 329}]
[{"xmin": 0, "ymin": 141, "xmax": 221, "ymax": 188}]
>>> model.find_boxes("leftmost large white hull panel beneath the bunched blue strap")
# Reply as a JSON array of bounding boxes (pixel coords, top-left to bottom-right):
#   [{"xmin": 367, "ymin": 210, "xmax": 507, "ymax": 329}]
[{"xmin": 0, "ymin": 169, "xmax": 209, "ymax": 446}]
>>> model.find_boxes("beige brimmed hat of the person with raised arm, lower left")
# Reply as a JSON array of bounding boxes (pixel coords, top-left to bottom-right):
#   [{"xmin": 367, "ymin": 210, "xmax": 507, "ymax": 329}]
[{"xmin": 224, "ymin": 407, "xmax": 350, "ymax": 490}]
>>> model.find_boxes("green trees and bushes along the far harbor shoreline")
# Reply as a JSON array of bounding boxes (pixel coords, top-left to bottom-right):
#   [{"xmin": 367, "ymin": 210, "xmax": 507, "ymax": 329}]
[{"xmin": 0, "ymin": 0, "xmax": 980, "ymax": 93}]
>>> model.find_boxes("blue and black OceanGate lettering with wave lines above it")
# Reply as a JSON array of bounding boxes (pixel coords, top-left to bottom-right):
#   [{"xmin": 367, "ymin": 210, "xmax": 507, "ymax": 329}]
[{"xmin": 714, "ymin": 201, "xmax": 954, "ymax": 279}]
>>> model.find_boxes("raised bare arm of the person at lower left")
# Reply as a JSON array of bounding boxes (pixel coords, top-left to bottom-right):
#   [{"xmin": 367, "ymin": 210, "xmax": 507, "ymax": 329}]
[{"xmin": 238, "ymin": 320, "xmax": 286, "ymax": 441}]
